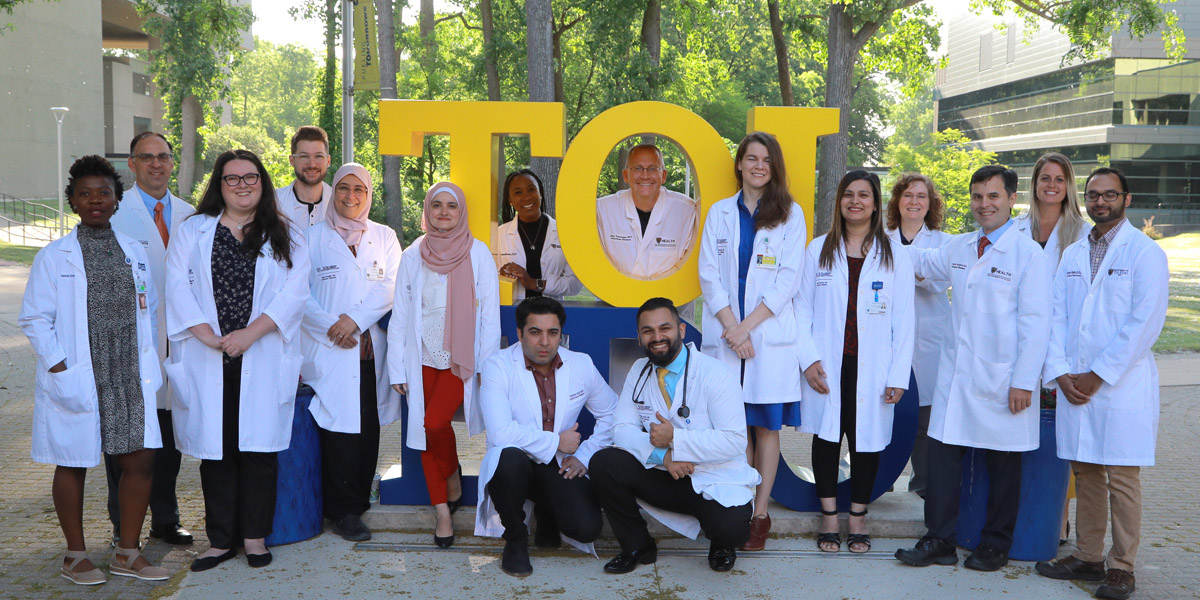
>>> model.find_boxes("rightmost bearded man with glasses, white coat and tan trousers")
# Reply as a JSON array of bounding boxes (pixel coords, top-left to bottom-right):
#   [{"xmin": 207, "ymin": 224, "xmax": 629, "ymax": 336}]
[{"xmin": 1037, "ymin": 168, "xmax": 1169, "ymax": 599}]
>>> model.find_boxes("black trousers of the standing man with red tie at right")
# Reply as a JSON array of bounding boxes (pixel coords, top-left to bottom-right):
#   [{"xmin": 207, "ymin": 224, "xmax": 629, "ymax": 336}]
[{"xmin": 925, "ymin": 438, "xmax": 1022, "ymax": 552}]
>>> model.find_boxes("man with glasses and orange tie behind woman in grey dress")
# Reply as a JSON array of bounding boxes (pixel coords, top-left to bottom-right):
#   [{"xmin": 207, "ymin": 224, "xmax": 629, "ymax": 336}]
[{"xmin": 104, "ymin": 131, "xmax": 196, "ymax": 544}]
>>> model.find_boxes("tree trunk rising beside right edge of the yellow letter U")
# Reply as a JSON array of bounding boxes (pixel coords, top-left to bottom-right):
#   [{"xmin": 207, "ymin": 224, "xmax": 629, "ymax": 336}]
[{"xmin": 812, "ymin": 2, "xmax": 858, "ymax": 236}]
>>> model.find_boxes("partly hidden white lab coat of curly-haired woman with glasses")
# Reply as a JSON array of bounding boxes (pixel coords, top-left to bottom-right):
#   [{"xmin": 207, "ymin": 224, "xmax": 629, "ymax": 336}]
[{"xmin": 888, "ymin": 226, "xmax": 952, "ymax": 407}]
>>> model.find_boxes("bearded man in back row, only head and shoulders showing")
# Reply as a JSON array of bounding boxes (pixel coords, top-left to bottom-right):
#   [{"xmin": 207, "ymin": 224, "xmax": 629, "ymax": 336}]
[{"xmin": 275, "ymin": 125, "xmax": 334, "ymax": 230}]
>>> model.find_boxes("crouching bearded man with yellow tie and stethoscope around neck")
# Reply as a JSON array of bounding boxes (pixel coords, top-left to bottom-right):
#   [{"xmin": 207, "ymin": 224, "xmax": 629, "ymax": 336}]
[{"xmin": 589, "ymin": 298, "xmax": 761, "ymax": 574}]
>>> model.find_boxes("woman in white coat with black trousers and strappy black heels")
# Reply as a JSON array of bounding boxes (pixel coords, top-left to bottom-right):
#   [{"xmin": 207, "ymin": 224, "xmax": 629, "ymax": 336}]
[{"xmin": 797, "ymin": 170, "xmax": 914, "ymax": 553}]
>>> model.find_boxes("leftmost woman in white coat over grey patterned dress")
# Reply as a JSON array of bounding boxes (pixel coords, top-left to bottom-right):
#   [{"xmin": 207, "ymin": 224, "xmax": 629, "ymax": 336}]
[{"xmin": 18, "ymin": 155, "xmax": 170, "ymax": 586}]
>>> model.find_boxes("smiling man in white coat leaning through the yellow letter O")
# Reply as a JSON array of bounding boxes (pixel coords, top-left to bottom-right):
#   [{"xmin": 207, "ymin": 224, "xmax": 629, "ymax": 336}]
[{"xmin": 596, "ymin": 144, "xmax": 697, "ymax": 280}]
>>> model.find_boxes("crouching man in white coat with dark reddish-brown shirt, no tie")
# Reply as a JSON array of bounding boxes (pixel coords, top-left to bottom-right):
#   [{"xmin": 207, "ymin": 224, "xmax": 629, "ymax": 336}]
[{"xmin": 475, "ymin": 296, "xmax": 617, "ymax": 577}]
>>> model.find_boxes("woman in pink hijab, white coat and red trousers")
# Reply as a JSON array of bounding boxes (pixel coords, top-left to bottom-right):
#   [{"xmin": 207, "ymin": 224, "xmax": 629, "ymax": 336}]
[{"xmin": 388, "ymin": 182, "xmax": 500, "ymax": 548}]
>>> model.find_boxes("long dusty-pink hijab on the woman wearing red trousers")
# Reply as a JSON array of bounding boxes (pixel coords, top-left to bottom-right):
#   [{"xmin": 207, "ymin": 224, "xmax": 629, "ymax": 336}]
[{"xmin": 421, "ymin": 181, "xmax": 475, "ymax": 382}]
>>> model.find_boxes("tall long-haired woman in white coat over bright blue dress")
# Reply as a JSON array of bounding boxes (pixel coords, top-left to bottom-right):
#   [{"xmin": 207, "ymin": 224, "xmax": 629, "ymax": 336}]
[{"xmin": 700, "ymin": 131, "xmax": 808, "ymax": 551}]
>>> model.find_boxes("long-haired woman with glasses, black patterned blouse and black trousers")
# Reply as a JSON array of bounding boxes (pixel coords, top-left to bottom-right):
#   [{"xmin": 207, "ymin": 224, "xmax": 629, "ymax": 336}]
[{"xmin": 166, "ymin": 150, "xmax": 308, "ymax": 571}]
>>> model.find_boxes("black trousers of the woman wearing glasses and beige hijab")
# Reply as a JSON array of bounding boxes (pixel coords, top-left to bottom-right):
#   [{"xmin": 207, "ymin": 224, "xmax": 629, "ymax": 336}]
[{"xmin": 317, "ymin": 359, "xmax": 379, "ymax": 521}]
